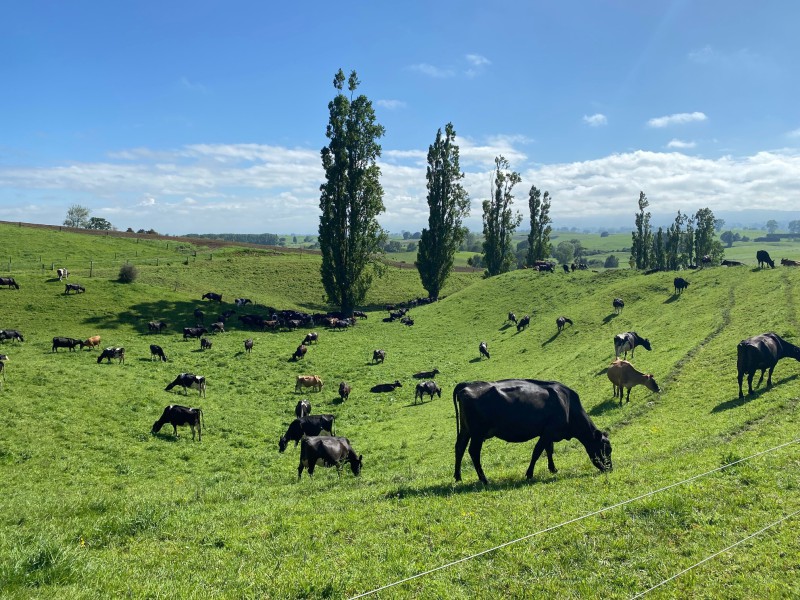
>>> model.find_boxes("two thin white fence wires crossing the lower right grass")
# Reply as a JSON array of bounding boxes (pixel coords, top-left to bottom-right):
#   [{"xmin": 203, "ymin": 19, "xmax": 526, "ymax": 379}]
[{"xmin": 350, "ymin": 438, "xmax": 800, "ymax": 600}]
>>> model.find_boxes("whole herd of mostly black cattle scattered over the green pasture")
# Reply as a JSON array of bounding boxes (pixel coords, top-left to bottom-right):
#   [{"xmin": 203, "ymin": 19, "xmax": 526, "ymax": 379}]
[{"xmin": 0, "ymin": 251, "xmax": 800, "ymax": 483}]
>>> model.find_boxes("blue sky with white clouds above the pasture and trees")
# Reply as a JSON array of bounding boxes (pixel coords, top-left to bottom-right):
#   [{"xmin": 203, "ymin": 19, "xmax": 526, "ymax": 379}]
[{"xmin": 0, "ymin": 0, "xmax": 800, "ymax": 234}]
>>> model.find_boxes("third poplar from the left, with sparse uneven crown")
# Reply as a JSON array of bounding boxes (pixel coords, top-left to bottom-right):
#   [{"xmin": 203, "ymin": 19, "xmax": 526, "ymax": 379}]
[{"xmin": 483, "ymin": 156, "xmax": 522, "ymax": 277}]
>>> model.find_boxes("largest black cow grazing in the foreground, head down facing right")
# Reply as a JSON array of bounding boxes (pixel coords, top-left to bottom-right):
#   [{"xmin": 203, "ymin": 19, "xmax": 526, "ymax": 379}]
[{"xmin": 453, "ymin": 379, "xmax": 612, "ymax": 484}]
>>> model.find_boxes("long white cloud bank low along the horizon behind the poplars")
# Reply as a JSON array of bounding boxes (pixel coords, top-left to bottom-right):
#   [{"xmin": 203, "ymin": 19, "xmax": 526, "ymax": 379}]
[{"xmin": 0, "ymin": 141, "xmax": 800, "ymax": 234}]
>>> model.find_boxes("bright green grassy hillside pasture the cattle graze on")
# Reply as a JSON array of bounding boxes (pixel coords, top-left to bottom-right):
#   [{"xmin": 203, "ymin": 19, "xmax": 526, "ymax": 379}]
[{"xmin": 0, "ymin": 226, "xmax": 800, "ymax": 598}]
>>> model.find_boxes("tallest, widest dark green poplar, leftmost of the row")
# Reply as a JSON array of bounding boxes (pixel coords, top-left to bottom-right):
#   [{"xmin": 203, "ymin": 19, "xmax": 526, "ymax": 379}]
[{"xmin": 319, "ymin": 69, "xmax": 386, "ymax": 316}]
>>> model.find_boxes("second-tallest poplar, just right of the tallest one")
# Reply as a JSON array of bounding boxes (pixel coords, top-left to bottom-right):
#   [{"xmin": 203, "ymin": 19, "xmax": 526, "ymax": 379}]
[{"xmin": 416, "ymin": 123, "xmax": 469, "ymax": 298}]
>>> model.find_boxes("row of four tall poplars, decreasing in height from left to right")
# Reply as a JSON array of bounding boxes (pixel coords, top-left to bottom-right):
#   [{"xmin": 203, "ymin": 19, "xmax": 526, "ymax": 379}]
[{"xmin": 319, "ymin": 69, "xmax": 551, "ymax": 315}]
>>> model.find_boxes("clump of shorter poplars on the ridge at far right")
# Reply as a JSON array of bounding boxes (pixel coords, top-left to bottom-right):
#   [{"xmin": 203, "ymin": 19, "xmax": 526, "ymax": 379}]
[{"xmin": 630, "ymin": 192, "xmax": 725, "ymax": 271}]
